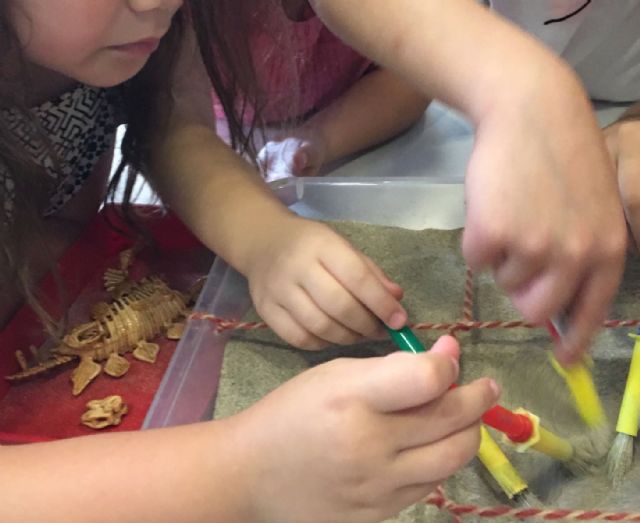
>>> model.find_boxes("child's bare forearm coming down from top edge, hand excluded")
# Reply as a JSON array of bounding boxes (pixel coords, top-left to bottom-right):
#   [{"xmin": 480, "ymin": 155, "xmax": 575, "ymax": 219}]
[{"xmin": 312, "ymin": 0, "xmax": 577, "ymax": 123}]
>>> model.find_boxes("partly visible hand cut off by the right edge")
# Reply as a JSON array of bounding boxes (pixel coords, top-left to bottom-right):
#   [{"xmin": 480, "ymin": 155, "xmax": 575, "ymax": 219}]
[{"xmin": 604, "ymin": 117, "xmax": 640, "ymax": 252}]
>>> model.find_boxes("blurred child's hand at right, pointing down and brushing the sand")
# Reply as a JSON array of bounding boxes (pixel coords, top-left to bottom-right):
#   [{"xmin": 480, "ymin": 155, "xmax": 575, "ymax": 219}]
[{"xmin": 463, "ymin": 73, "xmax": 626, "ymax": 363}]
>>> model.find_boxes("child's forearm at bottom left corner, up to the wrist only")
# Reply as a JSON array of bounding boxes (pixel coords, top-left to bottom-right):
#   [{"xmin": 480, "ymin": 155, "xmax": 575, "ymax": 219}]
[{"xmin": 0, "ymin": 419, "xmax": 255, "ymax": 523}]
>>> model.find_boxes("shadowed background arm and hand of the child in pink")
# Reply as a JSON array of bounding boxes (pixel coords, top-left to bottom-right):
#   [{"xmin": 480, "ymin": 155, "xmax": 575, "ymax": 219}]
[{"xmin": 260, "ymin": 69, "xmax": 429, "ymax": 179}]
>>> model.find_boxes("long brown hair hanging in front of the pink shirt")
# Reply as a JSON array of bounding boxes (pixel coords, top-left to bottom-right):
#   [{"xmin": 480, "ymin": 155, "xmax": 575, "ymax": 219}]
[{"xmin": 187, "ymin": 0, "xmax": 310, "ymax": 161}]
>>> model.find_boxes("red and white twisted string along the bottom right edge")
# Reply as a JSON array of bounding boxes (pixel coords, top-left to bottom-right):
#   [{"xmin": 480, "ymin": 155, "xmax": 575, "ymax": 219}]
[{"xmin": 425, "ymin": 487, "xmax": 640, "ymax": 522}]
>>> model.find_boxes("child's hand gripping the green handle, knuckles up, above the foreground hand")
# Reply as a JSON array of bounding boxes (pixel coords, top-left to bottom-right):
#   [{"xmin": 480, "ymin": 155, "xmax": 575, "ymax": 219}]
[{"xmin": 244, "ymin": 215, "xmax": 407, "ymax": 349}]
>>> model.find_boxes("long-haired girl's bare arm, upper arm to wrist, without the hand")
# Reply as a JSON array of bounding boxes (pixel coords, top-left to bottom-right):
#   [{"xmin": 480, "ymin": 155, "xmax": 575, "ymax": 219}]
[{"xmin": 147, "ymin": 28, "xmax": 291, "ymax": 274}]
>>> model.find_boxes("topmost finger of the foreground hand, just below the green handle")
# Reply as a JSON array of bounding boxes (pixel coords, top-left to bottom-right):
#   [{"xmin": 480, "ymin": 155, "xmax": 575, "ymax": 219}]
[{"xmin": 359, "ymin": 341, "xmax": 458, "ymax": 412}]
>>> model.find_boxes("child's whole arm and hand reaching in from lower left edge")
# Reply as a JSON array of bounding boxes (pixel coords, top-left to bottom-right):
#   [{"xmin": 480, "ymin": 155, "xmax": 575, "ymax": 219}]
[{"xmin": 0, "ymin": 337, "xmax": 498, "ymax": 523}]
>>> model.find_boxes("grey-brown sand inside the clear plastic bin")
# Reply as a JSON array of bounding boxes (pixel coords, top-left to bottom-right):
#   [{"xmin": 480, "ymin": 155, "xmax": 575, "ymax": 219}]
[{"xmin": 214, "ymin": 223, "xmax": 640, "ymax": 523}]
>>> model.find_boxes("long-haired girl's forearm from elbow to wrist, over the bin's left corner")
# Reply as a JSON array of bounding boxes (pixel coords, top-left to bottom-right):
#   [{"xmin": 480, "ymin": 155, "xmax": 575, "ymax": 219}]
[{"xmin": 149, "ymin": 122, "xmax": 293, "ymax": 275}]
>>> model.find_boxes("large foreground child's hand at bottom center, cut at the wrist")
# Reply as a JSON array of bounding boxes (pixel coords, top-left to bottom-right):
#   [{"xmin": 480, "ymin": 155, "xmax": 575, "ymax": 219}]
[{"xmin": 229, "ymin": 336, "xmax": 499, "ymax": 523}]
